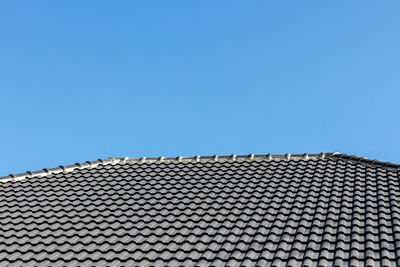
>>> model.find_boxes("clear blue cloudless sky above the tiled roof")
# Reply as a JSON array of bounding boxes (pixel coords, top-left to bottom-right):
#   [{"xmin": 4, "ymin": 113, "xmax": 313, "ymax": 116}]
[{"xmin": 0, "ymin": 0, "xmax": 400, "ymax": 176}]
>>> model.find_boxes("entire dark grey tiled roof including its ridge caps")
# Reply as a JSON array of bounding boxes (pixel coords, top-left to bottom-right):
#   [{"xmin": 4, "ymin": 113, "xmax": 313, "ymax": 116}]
[{"xmin": 0, "ymin": 153, "xmax": 400, "ymax": 266}]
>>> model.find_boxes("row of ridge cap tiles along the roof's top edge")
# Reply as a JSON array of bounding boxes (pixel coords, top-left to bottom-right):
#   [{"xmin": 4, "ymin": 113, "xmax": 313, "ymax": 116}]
[{"xmin": 0, "ymin": 152, "xmax": 400, "ymax": 182}]
